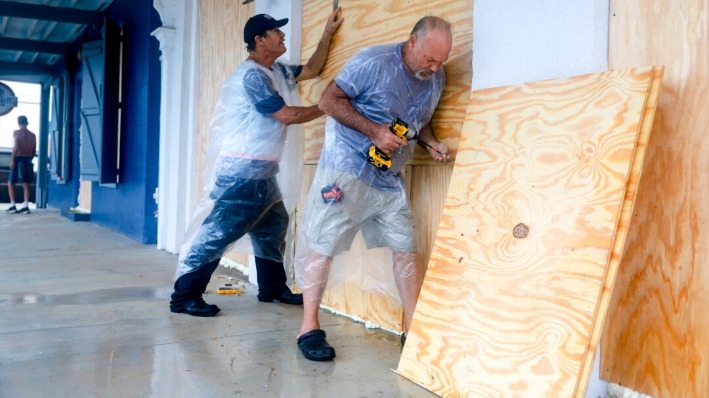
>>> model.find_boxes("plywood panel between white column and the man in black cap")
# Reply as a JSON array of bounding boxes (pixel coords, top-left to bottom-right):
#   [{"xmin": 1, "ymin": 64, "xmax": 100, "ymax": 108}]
[{"xmin": 195, "ymin": 0, "xmax": 254, "ymax": 267}]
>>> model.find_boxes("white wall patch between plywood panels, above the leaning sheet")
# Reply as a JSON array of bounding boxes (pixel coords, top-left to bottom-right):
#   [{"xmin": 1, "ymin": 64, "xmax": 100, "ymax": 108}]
[{"xmin": 473, "ymin": 0, "xmax": 610, "ymax": 90}]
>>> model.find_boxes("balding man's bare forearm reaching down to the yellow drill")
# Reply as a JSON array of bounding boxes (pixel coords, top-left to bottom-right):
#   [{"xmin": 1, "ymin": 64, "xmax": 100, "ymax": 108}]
[{"xmin": 320, "ymin": 81, "xmax": 406, "ymax": 153}]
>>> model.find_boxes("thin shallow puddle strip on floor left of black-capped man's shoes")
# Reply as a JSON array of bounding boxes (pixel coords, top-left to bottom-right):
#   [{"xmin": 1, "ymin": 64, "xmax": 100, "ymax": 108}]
[{"xmin": 0, "ymin": 287, "xmax": 172, "ymax": 305}]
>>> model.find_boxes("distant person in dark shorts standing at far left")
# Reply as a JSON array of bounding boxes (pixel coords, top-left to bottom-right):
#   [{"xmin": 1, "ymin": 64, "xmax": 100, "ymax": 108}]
[{"xmin": 5, "ymin": 116, "xmax": 37, "ymax": 214}]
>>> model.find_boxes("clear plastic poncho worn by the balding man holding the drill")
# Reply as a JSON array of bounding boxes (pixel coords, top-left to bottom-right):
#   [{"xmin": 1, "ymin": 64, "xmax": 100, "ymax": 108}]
[{"xmin": 295, "ymin": 44, "xmax": 445, "ymax": 302}]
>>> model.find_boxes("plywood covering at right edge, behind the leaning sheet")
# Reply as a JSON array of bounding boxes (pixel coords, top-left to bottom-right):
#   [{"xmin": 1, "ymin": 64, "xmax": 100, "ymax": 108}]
[{"xmin": 601, "ymin": 0, "xmax": 709, "ymax": 398}]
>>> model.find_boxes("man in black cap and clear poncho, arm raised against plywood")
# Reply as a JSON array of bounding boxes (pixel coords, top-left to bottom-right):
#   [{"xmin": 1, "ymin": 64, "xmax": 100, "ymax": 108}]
[{"xmin": 170, "ymin": 9, "xmax": 342, "ymax": 317}]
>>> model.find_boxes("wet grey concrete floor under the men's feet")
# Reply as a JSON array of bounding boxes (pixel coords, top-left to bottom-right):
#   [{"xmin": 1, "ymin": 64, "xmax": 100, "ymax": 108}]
[{"xmin": 0, "ymin": 210, "xmax": 434, "ymax": 398}]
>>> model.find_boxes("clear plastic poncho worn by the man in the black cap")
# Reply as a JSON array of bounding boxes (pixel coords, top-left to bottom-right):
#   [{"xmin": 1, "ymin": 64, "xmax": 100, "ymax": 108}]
[{"xmin": 175, "ymin": 61, "xmax": 304, "ymax": 279}]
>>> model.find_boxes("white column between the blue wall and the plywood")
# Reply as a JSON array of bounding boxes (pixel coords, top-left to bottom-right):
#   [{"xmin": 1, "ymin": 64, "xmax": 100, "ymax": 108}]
[{"xmin": 152, "ymin": 0, "xmax": 199, "ymax": 253}]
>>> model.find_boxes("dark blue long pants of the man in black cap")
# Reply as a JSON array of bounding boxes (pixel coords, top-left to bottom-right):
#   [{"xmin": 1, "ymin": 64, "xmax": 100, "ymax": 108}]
[{"xmin": 170, "ymin": 177, "xmax": 288, "ymax": 310}]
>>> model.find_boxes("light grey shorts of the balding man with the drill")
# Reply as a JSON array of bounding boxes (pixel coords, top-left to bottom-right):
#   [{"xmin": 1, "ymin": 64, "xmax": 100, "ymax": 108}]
[{"xmin": 304, "ymin": 167, "xmax": 416, "ymax": 257}]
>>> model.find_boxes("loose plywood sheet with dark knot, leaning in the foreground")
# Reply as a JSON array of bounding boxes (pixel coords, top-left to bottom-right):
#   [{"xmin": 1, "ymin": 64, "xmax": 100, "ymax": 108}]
[{"xmin": 397, "ymin": 67, "xmax": 662, "ymax": 398}]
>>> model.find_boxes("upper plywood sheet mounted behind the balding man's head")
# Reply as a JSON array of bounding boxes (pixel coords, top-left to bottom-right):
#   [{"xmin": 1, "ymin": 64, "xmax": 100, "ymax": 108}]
[{"xmin": 301, "ymin": 0, "xmax": 473, "ymax": 165}]
